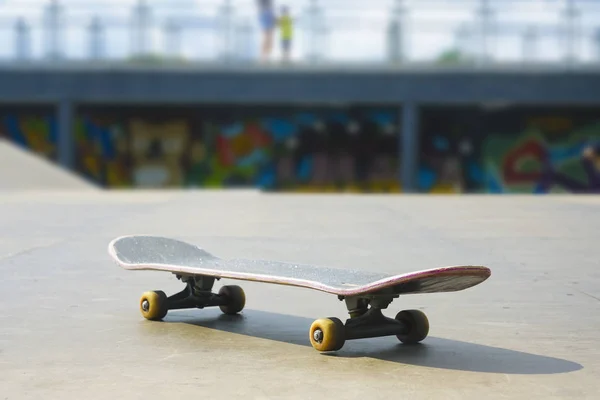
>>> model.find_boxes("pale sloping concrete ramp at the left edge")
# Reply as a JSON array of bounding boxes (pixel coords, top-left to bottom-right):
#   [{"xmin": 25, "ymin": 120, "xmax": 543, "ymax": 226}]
[{"xmin": 0, "ymin": 139, "xmax": 99, "ymax": 190}]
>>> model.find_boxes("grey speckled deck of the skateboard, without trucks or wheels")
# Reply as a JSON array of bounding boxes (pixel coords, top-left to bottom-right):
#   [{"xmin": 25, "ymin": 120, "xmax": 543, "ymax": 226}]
[{"xmin": 109, "ymin": 235, "xmax": 490, "ymax": 296}]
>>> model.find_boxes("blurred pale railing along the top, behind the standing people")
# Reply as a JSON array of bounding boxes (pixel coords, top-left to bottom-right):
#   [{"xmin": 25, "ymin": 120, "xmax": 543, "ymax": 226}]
[{"xmin": 0, "ymin": 0, "xmax": 600, "ymax": 65}]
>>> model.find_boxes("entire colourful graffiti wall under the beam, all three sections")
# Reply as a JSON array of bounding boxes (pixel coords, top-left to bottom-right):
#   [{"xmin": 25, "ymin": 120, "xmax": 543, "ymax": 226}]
[{"xmin": 0, "ymin": 105, "xmax": 600, "ymax": 193}]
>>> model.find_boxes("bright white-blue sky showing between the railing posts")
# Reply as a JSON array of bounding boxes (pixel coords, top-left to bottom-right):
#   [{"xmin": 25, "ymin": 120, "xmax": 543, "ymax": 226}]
[{"xmin": 0, "ymin": 0, "xmax": 600, "ymax": 61}]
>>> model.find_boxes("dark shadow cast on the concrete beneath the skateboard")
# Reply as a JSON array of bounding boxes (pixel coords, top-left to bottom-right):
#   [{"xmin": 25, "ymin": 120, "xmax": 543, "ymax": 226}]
[{"xmin": 165, "ymin": 309, "xmax": 583, "ymax": 374}]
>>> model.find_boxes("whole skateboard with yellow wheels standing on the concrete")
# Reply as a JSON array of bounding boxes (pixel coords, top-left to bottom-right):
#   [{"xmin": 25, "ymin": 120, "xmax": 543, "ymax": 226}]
[{"xmin": 108, "ymin": 235, "xmax": 491, "ymax": 352}]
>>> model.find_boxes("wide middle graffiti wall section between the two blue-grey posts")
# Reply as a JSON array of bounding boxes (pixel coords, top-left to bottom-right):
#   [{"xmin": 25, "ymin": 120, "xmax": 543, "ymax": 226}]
[{"xmin": 75, "ymin": 106, "xmax": 400, "ymax": 191}]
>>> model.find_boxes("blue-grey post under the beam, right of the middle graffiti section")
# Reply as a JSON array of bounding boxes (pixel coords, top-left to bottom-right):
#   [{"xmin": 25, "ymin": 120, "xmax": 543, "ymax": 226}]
[{"xmin": 399, "ymin": 100, "xmax": 419, "ymax": 193}]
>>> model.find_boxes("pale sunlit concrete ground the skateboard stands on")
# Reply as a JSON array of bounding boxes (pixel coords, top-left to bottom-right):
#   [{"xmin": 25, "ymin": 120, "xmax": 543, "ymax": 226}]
[{"xmin": 0, "ymin": 191, "xmax": 600, "ymax": 400}]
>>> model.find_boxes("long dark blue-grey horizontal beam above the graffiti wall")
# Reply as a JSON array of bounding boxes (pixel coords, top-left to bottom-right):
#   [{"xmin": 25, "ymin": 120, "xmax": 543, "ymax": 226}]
[{"xmin": 0, "ymin": 66, "xmax": 600, "ymax": 104}]
